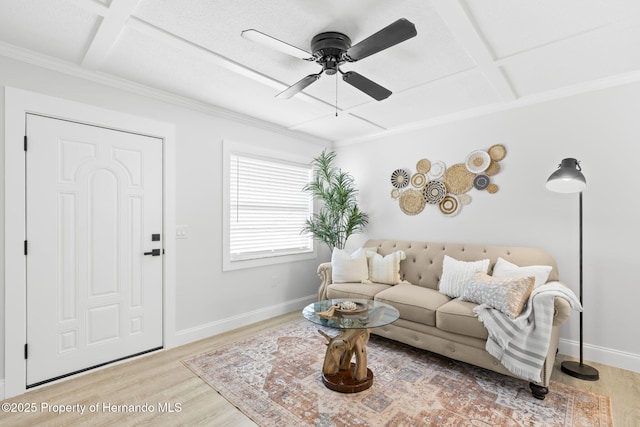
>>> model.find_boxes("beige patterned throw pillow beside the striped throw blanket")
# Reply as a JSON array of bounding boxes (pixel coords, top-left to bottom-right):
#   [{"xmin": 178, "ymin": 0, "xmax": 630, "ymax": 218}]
[{"xmin": 460, "ymin": 273, "xmax": 535, "ymax": 319}]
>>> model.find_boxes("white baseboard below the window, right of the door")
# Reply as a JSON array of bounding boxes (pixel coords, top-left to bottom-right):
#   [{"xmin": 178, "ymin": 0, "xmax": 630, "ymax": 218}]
[{"xmin": 172, "ymin": 295, "xmax": 317, "ymax": 346}]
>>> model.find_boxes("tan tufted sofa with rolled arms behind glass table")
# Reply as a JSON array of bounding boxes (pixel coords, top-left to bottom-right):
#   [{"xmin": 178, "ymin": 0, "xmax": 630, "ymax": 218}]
[{"xmin": 318, "ymin": 240, "xmax": 571, "ymax": 399}]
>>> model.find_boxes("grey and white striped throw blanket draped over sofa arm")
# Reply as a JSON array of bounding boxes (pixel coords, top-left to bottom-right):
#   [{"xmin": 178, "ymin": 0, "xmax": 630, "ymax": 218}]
[{"xmin": 473, "ymin": 282, "xmax": 582, "ymax": 382}]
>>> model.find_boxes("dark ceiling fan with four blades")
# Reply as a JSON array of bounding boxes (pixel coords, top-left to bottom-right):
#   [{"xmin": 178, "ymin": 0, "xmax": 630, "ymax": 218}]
[{"xmin": 241, "ymin": 18, "xmax": 418, "ymax": 101}]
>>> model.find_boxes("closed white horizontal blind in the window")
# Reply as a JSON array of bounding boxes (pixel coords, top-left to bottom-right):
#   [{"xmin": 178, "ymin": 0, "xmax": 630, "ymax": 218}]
[{"xmin": 229, "ymin": 154, "xmax": 313, "ymax": 261}]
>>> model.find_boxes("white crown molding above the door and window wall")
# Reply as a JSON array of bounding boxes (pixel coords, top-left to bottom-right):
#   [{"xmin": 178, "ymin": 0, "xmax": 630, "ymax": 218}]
[{"xmin": 0, "ymin": 41, "xmax": 332, "ymax": 146}]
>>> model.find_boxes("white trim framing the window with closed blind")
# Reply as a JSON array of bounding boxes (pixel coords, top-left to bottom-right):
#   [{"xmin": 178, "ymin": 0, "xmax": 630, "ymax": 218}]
[{"xmin": 222, "ymin": 140, "xmax": 318, "ymax": 271}]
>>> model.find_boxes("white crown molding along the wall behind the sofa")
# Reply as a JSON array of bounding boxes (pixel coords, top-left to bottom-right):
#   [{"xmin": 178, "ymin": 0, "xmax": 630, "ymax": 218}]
[{"xmin": 333, "ymin": 71, "xmax": 640, "ymax": 147}]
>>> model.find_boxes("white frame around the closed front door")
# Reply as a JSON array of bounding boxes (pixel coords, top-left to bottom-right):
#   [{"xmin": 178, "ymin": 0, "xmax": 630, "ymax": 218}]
[{"xmin": 0, "ymin": 87, "xmax": 176, "ymax": 398}]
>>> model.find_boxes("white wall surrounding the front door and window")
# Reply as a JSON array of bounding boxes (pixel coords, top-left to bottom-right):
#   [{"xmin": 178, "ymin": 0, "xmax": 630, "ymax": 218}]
[{"xmin": 0, "ymin": 53, "xmax": 328, "ymax": 392}]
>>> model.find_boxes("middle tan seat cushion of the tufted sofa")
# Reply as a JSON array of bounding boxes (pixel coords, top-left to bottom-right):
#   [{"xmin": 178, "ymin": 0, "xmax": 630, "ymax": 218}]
[{"xmin": 374, "ymin": 283, "xmax": 450, "ymax": 326}]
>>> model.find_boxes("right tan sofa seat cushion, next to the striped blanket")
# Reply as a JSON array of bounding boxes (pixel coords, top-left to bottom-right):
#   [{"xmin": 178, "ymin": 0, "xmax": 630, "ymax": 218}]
[{"xmin": 436, "ymin": 298, "xmax": 489, "ymax": 340}]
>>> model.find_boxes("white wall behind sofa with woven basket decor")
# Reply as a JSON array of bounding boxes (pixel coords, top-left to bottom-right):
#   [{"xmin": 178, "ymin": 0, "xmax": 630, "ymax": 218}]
[{"xmin": 337, "ymin": 83, "xmax": 640, "ymax": 371}]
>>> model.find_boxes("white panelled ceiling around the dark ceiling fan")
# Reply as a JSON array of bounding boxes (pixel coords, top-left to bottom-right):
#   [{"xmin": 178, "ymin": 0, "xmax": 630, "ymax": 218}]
[{"xmin": 0, "ymin": 0, "xmax": 640, "ymax": 143}]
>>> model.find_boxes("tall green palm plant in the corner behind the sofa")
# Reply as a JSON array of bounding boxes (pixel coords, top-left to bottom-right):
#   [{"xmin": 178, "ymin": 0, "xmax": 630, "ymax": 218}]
[{"xmin": 302, "ymin": 150, "xmax": 369, "ymax": 250}]
